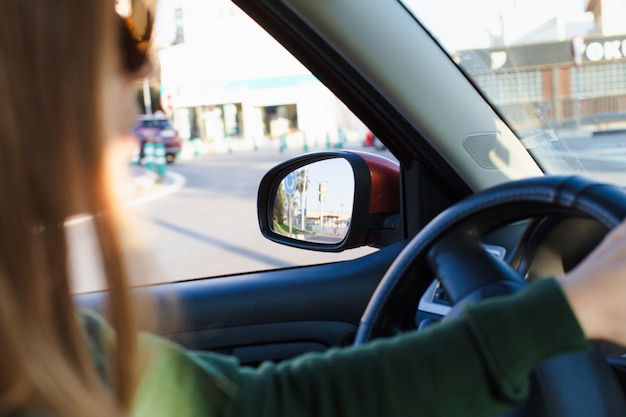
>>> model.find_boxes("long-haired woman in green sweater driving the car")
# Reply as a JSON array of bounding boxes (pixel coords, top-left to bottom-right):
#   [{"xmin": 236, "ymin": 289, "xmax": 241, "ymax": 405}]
[{"xmin": 0, "ymin": 0, "xmax": 626, "ymax": 417}]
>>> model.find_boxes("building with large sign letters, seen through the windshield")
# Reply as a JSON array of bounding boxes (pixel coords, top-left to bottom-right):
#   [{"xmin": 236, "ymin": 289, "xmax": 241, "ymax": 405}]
[{"xmin": 457, "ymin": 0, "xmax": 626, "ymax": 131}]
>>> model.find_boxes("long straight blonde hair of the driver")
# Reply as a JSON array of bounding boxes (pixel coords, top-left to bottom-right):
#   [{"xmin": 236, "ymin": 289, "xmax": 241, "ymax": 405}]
[{"xmin": 0, "ymin": 0, "xmax": 136, "ymax": 416}]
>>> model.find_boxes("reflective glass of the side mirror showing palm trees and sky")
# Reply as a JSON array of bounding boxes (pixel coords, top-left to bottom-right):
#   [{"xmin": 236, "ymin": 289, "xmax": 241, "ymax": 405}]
[{"xmin": 272, "ymin": 158, "xmax": 354, "ymax": 245}]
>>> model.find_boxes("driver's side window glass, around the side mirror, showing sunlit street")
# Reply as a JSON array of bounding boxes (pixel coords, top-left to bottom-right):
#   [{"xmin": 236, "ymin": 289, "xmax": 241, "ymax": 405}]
[{"xmin": 119, "ymin": 0, "xmax": 393, "ymax": 281}]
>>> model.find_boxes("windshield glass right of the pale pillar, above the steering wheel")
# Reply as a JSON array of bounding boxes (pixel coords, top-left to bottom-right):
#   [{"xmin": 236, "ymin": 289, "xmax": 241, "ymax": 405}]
[{"xmin": 403, "ymin": 0, "xmax": 626, "ymax": 185}]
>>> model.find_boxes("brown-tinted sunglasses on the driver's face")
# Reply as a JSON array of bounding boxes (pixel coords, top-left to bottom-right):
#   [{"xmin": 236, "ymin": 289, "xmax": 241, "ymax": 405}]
[{"xmin": 116, "ymin": 0, "xmax": 155, "ymax": 72}]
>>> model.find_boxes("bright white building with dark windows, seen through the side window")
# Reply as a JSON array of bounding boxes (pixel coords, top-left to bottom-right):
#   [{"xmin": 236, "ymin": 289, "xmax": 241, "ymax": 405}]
[{"xmin": 157, "ymin": 0, "xmax": 366, "ymax": 151}]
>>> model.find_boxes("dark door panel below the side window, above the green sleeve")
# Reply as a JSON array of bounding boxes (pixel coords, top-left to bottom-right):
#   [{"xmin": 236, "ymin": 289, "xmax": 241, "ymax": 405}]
[{"xmin": 75, "ymin": 241, "xmax": 406, "ymax": 364}]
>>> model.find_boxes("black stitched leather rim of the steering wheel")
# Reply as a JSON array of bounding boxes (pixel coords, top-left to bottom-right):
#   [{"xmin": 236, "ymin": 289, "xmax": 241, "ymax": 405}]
[{"xmin": 355, "ymin": 176, "xmax": 626, "ymax": 344}]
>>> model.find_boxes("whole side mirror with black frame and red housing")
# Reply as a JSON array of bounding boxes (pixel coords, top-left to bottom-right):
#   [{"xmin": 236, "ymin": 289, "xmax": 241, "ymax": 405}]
[{"xmin": 257, "ymin": 151, "xmax": 401, "ymax": 252}]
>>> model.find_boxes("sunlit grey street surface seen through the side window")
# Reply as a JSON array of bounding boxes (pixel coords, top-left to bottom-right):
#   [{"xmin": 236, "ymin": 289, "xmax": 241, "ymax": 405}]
[{"xmin": 69, "ymin": 145, "xmax": 388, "ymax": 292}]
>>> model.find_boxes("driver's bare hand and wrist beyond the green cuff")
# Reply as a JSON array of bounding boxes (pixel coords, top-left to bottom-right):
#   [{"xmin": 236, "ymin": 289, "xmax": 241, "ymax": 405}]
[{"xmin": 560, "ymin": 218, "xmax": 626, "ymax": 346}]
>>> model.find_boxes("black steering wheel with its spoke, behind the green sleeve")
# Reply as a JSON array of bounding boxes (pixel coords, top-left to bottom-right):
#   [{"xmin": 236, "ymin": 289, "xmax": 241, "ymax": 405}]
[{"xmin": 355, "ymin": 176, "xmax": 626, "ymax": 417}]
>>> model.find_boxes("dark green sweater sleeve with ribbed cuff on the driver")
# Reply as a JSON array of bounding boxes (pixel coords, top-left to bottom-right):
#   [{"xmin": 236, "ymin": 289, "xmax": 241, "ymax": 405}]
[{"xmin": 23, "ymin": 279, "xmax": 589, "ymax": 417}]
